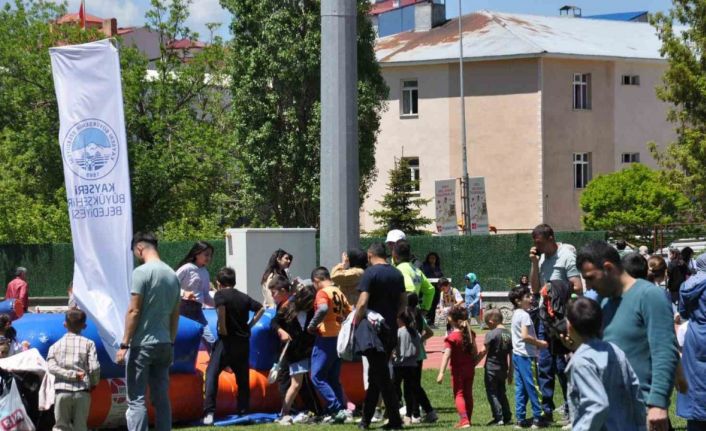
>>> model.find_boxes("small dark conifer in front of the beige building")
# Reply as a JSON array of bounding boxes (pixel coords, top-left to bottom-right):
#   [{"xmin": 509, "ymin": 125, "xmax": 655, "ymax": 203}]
[{"xmin": 370, "ymin": 159, "xmax": 433, "ymax": 236}]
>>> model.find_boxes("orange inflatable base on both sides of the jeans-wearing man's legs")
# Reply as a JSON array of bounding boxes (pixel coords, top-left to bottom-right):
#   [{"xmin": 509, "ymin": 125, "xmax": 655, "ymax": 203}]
[{"xmin": 88, "ymin": 372, "xmax": 203, "ymax": 428}]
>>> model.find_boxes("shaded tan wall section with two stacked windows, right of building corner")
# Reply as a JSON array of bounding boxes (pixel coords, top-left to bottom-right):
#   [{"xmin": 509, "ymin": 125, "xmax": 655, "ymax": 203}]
[{"xmin": 542, "ymin": 58, "xmax": 616, "ymax": 230}]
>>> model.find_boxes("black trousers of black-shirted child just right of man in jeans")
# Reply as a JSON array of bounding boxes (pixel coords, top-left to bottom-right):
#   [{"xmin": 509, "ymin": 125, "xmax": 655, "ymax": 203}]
[{"xmin": 203, "ymin": 337, "xmax": 250, "ymax": 414}]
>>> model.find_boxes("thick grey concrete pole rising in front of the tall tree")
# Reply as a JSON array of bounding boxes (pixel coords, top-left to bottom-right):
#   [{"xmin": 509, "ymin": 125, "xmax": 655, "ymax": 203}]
[{"xmin": 319, "ymin": 0, "xmax": 360, "ymax": 269}]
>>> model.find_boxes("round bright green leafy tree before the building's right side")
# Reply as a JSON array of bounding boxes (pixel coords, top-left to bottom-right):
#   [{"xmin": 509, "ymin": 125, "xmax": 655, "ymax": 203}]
[{"xmin": 580, "ymin": 163, "xmax": 689, "ymax": 238}]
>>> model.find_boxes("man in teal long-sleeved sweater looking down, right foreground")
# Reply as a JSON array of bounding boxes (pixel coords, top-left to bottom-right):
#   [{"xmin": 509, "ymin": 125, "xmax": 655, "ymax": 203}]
[{"xmin": 576, "ymin": 241, "xmax": 679, "ymax": 431}]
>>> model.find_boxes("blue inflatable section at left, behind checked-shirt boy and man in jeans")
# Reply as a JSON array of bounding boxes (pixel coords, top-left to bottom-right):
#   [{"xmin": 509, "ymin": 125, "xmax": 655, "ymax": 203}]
[{"xmin": 12, "ymin": 314, "xmax": 204, "ymax": 379}]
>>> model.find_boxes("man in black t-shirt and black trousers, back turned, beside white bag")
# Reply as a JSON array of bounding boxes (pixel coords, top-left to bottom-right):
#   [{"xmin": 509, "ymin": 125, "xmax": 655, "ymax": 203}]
[{"xmin": 355, "ymin": 243, "xmax": 407, "ymax": 429}]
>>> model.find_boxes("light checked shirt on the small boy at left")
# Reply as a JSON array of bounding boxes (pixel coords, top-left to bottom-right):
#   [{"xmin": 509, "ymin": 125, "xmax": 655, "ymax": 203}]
[{"xmin": 47, "ymin": 332, "xmax": 100, "ymax": 392}]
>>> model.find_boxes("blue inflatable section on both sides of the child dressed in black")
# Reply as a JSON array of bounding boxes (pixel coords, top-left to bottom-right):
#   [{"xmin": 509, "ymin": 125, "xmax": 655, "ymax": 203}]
[{"xmin": 201, "ymin": 308, "xmax": 279, "ymax": 371}]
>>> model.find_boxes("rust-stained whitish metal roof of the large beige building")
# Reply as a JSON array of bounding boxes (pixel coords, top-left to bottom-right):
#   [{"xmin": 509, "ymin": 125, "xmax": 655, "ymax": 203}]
[{"xmin": 375, "ymin": 11, "xmax": 662, "ymax": 64}]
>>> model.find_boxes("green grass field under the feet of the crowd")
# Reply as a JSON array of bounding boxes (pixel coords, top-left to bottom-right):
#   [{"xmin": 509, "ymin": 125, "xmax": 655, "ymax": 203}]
[{"xmin": 180, "ymin": 369, "xmax": 686, "ymax": 431}]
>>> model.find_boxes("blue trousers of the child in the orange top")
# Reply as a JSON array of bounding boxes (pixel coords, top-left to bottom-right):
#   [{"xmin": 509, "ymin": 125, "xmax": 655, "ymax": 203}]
[{"xmin": 311, "ymin": 337, "xmax": 344, "ymax": 414}]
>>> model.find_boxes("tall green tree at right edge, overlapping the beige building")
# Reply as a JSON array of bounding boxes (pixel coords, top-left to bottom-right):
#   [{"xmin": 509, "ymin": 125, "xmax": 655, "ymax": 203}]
[{"xmin": 650, "ymin": 4, "xmax": 706, "ymax": 218}]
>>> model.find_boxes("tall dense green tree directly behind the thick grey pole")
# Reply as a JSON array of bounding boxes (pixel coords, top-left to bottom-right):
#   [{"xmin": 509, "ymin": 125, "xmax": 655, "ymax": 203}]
[{"xmin": 221, "ymin": 0, "xmax": 387, "ymax": 230}]
